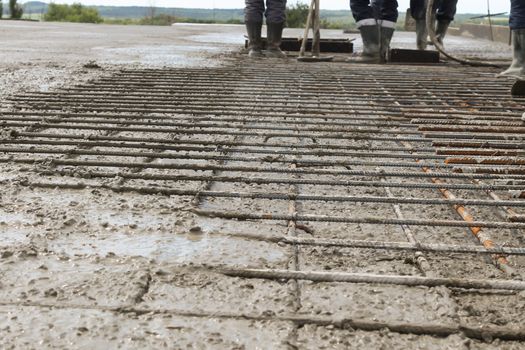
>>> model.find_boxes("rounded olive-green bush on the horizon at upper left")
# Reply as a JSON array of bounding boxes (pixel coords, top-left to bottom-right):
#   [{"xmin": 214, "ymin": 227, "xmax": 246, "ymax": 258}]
[{"xmin": 44, "ymin": 3, "xmax": 104, "ymax": 23}]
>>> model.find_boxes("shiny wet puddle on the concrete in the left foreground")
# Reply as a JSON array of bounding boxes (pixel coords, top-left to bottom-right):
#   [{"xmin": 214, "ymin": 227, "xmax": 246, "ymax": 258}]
[{"xmin": 48, "ymin": 233, "xmax": 285, "ymax": 264}]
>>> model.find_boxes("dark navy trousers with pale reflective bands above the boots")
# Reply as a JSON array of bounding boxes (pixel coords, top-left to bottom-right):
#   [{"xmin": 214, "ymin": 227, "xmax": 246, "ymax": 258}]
[{"xmin": 350, "ymin": 0, "xmax": 398, "ymax": 28}]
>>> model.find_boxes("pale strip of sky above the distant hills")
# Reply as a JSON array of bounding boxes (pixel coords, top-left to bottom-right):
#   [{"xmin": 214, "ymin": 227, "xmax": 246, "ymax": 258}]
[{"xmin": 30, "ymin": 0, "xmax": 510, "ymax": 13}]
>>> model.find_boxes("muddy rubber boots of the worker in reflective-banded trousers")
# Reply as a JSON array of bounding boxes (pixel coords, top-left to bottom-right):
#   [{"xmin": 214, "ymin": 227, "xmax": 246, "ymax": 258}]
[{"xmin": 347, "ymin": 24, "xmax": 394, "ymax": 63}]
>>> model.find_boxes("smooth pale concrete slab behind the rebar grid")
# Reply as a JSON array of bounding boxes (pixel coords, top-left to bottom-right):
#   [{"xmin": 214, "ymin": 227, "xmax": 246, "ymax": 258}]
[{"xmin": 0, "ymin": 21, "xmax": 511, "ymax": 97}]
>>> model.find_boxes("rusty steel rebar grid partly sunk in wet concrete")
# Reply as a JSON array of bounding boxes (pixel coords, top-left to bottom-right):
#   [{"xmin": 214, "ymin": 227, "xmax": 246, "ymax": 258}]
[{"xmin": 0, "ymin": 62, "xmax": 525, "ymax": 340}]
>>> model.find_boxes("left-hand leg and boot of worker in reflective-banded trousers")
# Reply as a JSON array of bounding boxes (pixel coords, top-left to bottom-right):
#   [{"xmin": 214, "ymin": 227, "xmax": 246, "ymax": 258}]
[{"xmin": 348, "ymin": 0, "xmax": 380, "ymax": 63}]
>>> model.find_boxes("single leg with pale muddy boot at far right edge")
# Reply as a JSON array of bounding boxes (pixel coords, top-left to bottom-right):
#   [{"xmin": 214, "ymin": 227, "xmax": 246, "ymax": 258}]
[{"xmin": 501, "ymin": 0, "xmax": 525, "ymax": 77}]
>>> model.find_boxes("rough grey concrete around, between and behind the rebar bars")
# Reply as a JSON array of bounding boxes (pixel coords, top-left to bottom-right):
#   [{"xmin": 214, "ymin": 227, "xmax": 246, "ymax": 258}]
[{"xmin": 0, "ymin": 22, "xmax": 525, "ymax": 350}]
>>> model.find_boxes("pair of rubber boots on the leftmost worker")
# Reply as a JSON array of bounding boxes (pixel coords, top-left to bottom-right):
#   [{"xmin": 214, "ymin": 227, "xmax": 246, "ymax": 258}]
[{"xmin": 246, "ymin": 22, "xmax": 286, "ymax": 58}]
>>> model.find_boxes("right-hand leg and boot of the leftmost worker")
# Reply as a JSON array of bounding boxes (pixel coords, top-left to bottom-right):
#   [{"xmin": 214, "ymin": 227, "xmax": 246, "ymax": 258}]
[{"xmin": 266, "ymin": 0, "xmax": 286, "ymax": 58}]
